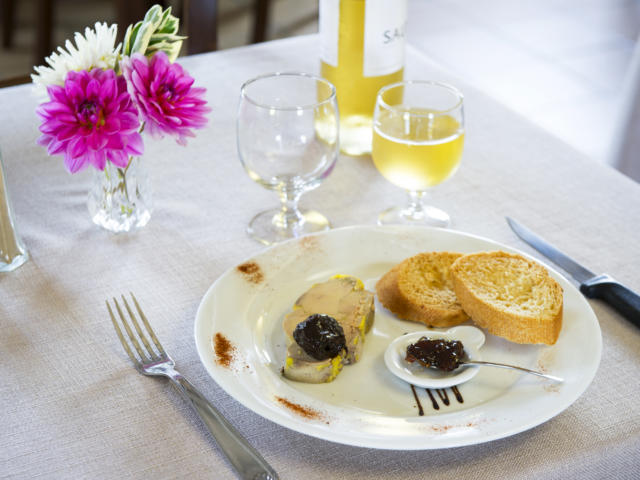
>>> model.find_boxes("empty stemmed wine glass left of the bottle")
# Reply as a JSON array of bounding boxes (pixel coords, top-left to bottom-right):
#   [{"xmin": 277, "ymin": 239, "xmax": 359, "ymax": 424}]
[{"xmin": 237, "ymin": 73, "xmax": 339, "ymax": 245}]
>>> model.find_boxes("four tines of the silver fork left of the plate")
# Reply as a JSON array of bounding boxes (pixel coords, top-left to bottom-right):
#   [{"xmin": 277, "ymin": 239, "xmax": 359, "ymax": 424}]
[{"xmin": 105, "ymin": 292, "xmax": 167, "ymax": 367}]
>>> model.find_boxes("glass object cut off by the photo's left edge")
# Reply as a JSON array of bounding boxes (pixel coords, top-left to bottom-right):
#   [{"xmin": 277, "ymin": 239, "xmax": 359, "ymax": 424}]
[{"xmin": 0, "ymin": 150, "xmax": 29, "ymax": 272}]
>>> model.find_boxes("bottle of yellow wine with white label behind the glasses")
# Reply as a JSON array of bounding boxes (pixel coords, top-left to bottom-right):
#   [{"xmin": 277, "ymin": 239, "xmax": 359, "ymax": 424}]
[{"xmin": 319, "ymin": 0, "xmax": 407, "ymax": 155}]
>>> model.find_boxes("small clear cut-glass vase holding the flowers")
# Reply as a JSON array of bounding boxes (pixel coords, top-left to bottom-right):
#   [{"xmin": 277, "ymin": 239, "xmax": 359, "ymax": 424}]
[{"xmin": 87, "ymin": 157, "xmax": 153, "ymax": 233}]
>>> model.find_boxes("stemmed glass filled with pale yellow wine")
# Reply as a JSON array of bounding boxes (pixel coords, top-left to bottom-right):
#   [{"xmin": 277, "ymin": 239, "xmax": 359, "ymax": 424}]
[{"xmin": 372, "ymin": 81, "xmax": 464, "ymax": 227}]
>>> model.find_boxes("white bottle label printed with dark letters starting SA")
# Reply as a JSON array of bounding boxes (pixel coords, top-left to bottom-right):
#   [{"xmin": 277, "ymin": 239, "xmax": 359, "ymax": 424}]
[{"xmin": 362, "ymin": 0, "xmax": 407, "ymax": 77}]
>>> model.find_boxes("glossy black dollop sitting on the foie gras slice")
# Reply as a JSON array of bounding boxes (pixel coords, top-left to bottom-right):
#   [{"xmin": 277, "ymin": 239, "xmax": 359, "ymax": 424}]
[{"xmin": 293, "ymin": 313, "xmax": 347, "ymax": 360}]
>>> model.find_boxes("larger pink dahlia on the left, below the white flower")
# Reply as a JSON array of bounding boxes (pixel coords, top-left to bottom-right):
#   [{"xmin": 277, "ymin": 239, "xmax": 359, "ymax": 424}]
[{"xmin": 36, "ymin": 69, "xmax": 144, "ymax": 173}]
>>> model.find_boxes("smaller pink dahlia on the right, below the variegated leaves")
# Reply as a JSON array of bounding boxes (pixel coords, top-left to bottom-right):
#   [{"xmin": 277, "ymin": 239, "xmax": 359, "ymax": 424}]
[{"xmin": 120, "ymin": 51, "xmax": 211, "ymax": 145}]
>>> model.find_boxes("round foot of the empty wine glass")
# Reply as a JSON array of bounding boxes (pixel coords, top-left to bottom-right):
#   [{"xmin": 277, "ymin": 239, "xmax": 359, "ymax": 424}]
[{"xmin": 247, "ymin": 208, "xmax": 331, "ymax": 245}]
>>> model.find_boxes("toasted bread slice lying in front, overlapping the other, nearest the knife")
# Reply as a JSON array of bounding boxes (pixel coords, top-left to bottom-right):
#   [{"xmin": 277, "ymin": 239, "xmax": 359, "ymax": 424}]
[{"xmin": 451, "ymin": 251, "xmax": 563, "ymax": 345}]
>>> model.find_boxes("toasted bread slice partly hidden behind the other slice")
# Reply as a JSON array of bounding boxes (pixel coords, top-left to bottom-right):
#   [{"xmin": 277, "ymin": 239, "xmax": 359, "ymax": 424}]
[{"xmin": 376, "ymin": 252, "xmax": 469, "ymax": 327}]
